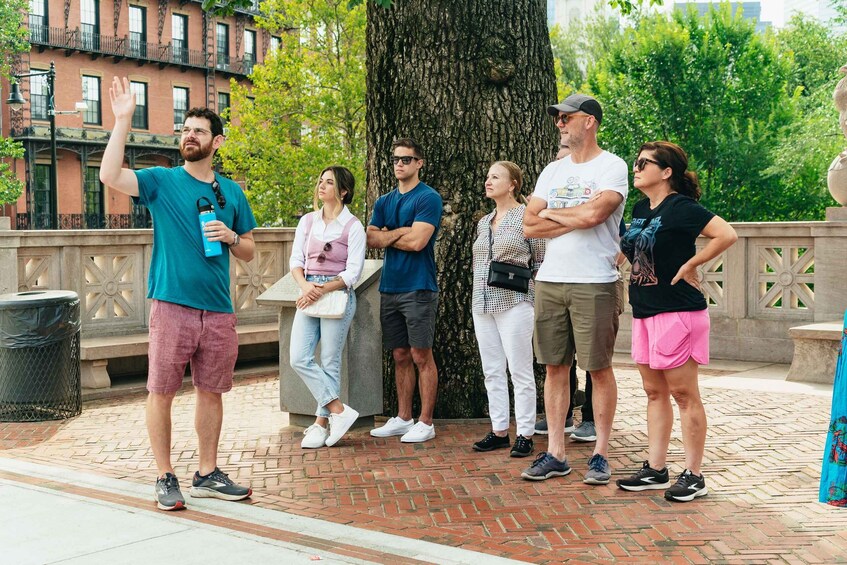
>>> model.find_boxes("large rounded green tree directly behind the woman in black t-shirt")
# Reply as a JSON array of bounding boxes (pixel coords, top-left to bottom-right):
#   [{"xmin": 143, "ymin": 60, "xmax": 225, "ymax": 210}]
[{"xmin": 587, "ymin": 3, "xmax": 798, "ymax": 221}]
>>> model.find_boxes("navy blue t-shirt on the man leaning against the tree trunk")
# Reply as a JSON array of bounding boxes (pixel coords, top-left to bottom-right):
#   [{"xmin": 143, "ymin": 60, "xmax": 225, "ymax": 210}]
[{"xmin": 370, "ymin": 182, "xmax": 444, "ymax": 294}]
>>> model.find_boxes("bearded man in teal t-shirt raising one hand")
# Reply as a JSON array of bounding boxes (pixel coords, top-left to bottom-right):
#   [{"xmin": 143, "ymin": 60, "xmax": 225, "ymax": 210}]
[{"xmin": 100, "ymin": 77, "xmax": 256, "ymax": 510}]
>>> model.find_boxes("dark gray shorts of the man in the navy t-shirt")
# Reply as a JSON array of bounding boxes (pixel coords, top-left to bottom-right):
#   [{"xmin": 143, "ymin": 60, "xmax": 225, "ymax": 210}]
[{"xmin": 379, "ymin": 290, "xmax": 438, "ymax": 349}]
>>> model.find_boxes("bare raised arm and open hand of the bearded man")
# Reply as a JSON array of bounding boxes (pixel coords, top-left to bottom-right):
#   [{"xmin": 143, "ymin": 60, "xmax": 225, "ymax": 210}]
[{"xmin": 100, "ymin": 77, "xmax": 138, "ymax": 196}]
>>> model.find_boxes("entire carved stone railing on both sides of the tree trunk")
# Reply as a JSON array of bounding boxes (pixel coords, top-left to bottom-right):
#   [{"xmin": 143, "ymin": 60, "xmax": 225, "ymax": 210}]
[{"xmin": 0, "ymin": 217, "xmax": 847, "ymax": 363}]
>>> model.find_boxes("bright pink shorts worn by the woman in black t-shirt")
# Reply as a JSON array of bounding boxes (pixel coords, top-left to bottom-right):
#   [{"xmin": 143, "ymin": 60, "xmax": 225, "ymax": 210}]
[{"xmin": 632, "ymin": 310, "xmax": 710, "ymax": 371}]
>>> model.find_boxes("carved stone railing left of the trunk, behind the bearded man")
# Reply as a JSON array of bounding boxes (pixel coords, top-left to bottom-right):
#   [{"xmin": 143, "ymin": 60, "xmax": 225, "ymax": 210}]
[{"xmin": 0, "ymin": 228, "xmax": 294, "ymax": 337}]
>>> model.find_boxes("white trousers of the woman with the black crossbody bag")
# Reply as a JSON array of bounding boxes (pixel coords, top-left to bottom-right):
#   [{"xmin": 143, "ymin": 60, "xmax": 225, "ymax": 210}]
[{"xmin": 473, "ymin": 302, "xmax": 536, "ymax": 437}]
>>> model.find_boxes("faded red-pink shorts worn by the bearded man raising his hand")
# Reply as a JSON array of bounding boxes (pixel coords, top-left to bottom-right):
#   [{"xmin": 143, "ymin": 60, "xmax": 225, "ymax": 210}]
[{"xmin": 147, "ymin": 300, "xmax": 238, "ymax": 394}]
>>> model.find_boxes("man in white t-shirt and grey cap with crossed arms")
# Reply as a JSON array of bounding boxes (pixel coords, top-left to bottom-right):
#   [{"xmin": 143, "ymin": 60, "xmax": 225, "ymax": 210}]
[{"xmin": 521, "ymin": 94, "xmax": 628, "ymax": 484}]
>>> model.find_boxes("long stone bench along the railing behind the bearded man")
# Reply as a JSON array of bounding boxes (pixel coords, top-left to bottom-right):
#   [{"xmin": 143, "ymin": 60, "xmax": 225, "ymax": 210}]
[{"xmin": 80, "ymin": 323, "xmax": 279, "ymax": 388}]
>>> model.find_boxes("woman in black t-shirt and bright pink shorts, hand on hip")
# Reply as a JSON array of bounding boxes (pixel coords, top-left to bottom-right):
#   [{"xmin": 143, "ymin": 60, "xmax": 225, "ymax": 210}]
[{"xmin": 617, "ymin": 141, "xmax": 737, "ymax": 502}]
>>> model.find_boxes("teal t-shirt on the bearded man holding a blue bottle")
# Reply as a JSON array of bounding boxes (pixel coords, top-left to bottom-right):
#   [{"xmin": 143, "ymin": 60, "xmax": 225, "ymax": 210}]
[{"xmin": 135, "ymin": 167, "xmax": 256, "ymax": 312}]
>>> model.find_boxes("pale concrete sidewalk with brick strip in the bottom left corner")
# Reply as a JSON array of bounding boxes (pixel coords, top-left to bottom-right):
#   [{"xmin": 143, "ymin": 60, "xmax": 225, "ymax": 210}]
[{"xmin": 0, "ymin": 457, "xmax": 513, "ymax": 565}]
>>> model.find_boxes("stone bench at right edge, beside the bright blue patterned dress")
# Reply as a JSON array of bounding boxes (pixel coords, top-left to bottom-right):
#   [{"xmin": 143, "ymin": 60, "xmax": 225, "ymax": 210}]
[{"xmin": 786, "ymin": 322, "xmax": 844, "ymax": 384}]
